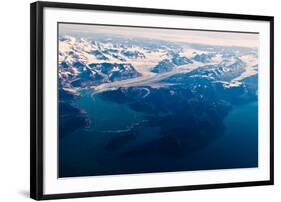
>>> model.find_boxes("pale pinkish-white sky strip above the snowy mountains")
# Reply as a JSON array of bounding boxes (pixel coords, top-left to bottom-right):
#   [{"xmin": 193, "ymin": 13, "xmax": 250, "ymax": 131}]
[{"xmin": 59, "ymin": 24, "xmax": 259, "ymax": 48}]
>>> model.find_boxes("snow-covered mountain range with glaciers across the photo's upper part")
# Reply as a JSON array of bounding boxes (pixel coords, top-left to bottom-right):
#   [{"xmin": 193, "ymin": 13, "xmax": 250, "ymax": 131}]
[{"xmin": 59, "ymin": 36, "xmax": 258, "ymax": 90}]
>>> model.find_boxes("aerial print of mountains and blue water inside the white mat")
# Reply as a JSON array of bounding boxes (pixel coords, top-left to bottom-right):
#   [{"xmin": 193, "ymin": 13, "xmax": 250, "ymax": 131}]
[{"xmin": 57, "ymin": 22, "xmax": 259, "ymax": 178}]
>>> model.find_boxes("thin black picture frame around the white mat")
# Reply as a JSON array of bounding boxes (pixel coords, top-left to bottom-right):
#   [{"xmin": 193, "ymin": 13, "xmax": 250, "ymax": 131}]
[{"xmin": 30, "ymin": 2, "xmax": 274, "ymax": 200}]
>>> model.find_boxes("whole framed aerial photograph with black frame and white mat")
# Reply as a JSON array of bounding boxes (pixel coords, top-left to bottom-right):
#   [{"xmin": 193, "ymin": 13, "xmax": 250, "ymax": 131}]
[{"xmin": 30, "ymin": 2, "xmax": 274, "ymax": 200}]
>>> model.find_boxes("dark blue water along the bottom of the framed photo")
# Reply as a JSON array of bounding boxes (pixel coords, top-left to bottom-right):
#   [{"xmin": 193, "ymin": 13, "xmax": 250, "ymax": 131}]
[{"xmin": 59, "ymin": 92, "xmax": 258, "ymax": 177}]
